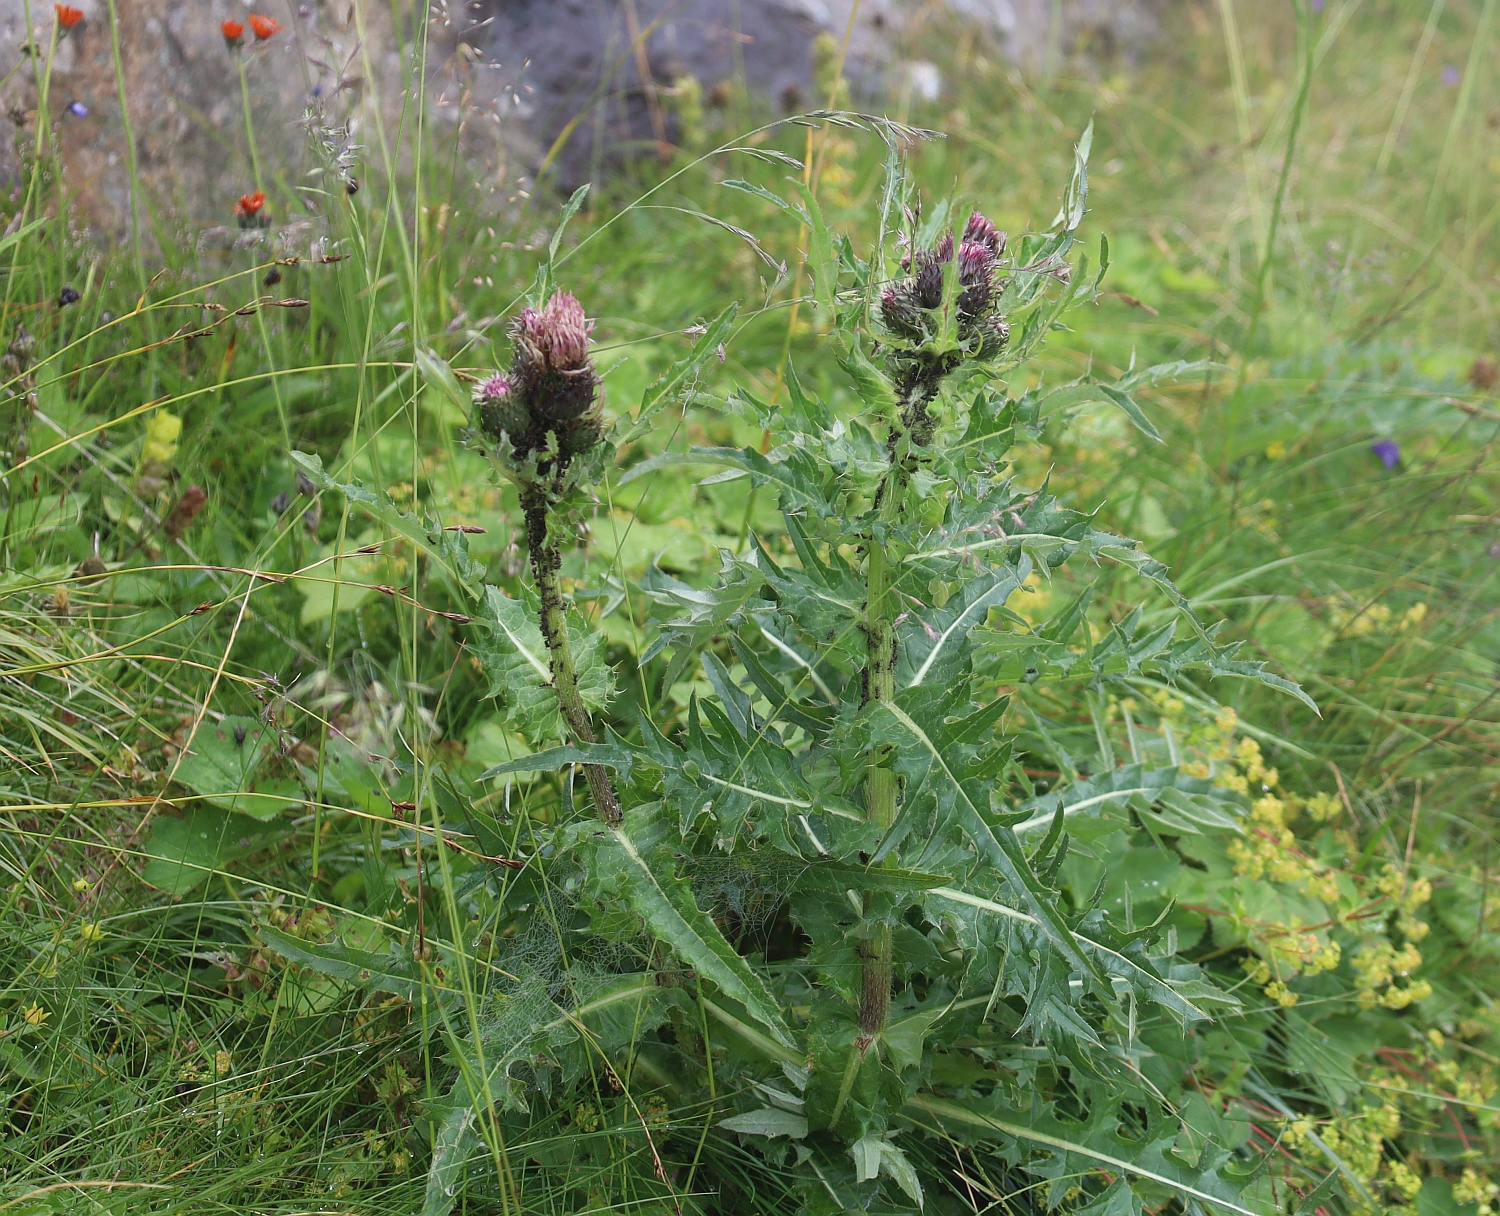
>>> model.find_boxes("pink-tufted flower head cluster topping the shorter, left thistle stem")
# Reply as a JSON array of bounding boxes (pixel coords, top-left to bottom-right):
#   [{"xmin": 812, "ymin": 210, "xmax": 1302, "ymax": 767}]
[{"xmin": 474, "ymin": 291, "xmax": 605, "ymax": 472}]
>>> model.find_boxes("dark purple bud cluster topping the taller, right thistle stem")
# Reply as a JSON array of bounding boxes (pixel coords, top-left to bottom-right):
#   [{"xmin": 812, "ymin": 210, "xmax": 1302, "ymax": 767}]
[{"xmin": 881, "ymin": 211, "xmax": 1010, "ymax": 442}]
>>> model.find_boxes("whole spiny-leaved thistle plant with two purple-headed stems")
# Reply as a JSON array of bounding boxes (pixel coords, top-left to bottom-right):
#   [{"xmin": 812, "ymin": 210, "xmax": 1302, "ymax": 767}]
[{"xmin": 428, "ymin": 130, "xmax": 1320, "ymax": 1212}]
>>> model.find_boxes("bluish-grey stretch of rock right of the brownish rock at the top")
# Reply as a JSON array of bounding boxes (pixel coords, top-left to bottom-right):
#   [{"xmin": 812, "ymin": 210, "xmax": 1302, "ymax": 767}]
[{"xmin": 464, "ymin": 0, "xmax": 1163, "ymax": 186}]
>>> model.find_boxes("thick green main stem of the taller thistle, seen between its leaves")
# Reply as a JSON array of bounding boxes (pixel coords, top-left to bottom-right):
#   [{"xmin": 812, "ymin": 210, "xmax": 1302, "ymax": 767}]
[{"xmin": 860, "ymin": 459, "xmax": 908, "ymax": 1045}]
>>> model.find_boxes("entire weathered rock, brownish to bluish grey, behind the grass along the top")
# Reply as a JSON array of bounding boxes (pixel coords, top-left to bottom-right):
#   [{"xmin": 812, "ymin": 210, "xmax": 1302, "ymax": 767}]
[{"xmin": 0, "ymin": 0, "xmax": 1164, "ymax": 242}]
